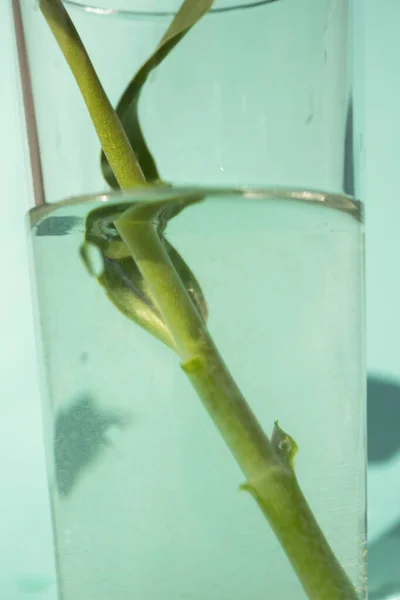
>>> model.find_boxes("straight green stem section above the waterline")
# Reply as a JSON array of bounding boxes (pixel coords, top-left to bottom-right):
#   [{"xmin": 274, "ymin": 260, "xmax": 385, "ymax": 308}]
[{"xmin": 40, "ymin": 0, "xmax": 145, "ymax": 188}]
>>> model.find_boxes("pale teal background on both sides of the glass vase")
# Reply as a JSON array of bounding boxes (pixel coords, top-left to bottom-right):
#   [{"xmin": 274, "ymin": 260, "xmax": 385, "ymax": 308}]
[{"xmin": 0, "ymin": 0, "xmax": 400, "ymax": 600}]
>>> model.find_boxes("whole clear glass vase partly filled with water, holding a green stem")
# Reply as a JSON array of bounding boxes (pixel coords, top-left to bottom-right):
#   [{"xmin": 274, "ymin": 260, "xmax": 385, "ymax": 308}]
[{"xmin": 14, "ymin": 0, "xmax": 366, "ymax": 600}]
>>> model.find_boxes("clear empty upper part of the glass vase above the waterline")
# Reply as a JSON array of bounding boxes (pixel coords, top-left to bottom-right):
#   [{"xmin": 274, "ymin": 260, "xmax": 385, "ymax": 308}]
[{"xmin": 14, "ymin": 0, "xmax": 354, "ymax": 202}]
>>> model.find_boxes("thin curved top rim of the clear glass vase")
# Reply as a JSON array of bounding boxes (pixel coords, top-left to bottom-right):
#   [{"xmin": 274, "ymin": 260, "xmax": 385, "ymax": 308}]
[{"xmin": 62, "ymin": 0, "xmax": 278, "ymax": 17}]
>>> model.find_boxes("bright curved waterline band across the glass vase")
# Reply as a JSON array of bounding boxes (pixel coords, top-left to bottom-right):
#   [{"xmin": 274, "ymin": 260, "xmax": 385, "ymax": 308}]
[{"xmin": 28, "ymin": 185, "xmax": 363, "ymax": 227}]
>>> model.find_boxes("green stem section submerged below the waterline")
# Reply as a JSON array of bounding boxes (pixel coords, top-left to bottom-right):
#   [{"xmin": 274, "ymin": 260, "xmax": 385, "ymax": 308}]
[{"xmin": 115, "ymin": 207, "xmax": 357, "ymax": 600}]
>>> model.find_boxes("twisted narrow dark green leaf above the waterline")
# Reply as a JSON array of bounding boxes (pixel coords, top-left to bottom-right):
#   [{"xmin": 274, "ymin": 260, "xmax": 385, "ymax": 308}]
[{"xmin": 101, "ymin": 0, "xmax": 214, "ymax": 189}]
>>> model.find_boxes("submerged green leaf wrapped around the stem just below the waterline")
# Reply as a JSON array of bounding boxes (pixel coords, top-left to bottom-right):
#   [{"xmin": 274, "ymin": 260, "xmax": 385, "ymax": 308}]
[{"xmin": 81, "ymin": 197, "xmax": 207, "ymax": 348}]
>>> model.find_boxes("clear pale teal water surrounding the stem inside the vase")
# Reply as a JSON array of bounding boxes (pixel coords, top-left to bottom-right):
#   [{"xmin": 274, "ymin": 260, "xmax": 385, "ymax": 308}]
[{"xmin": 28, "ymin": 194, "xmax": 365, "ymax": 600}]
